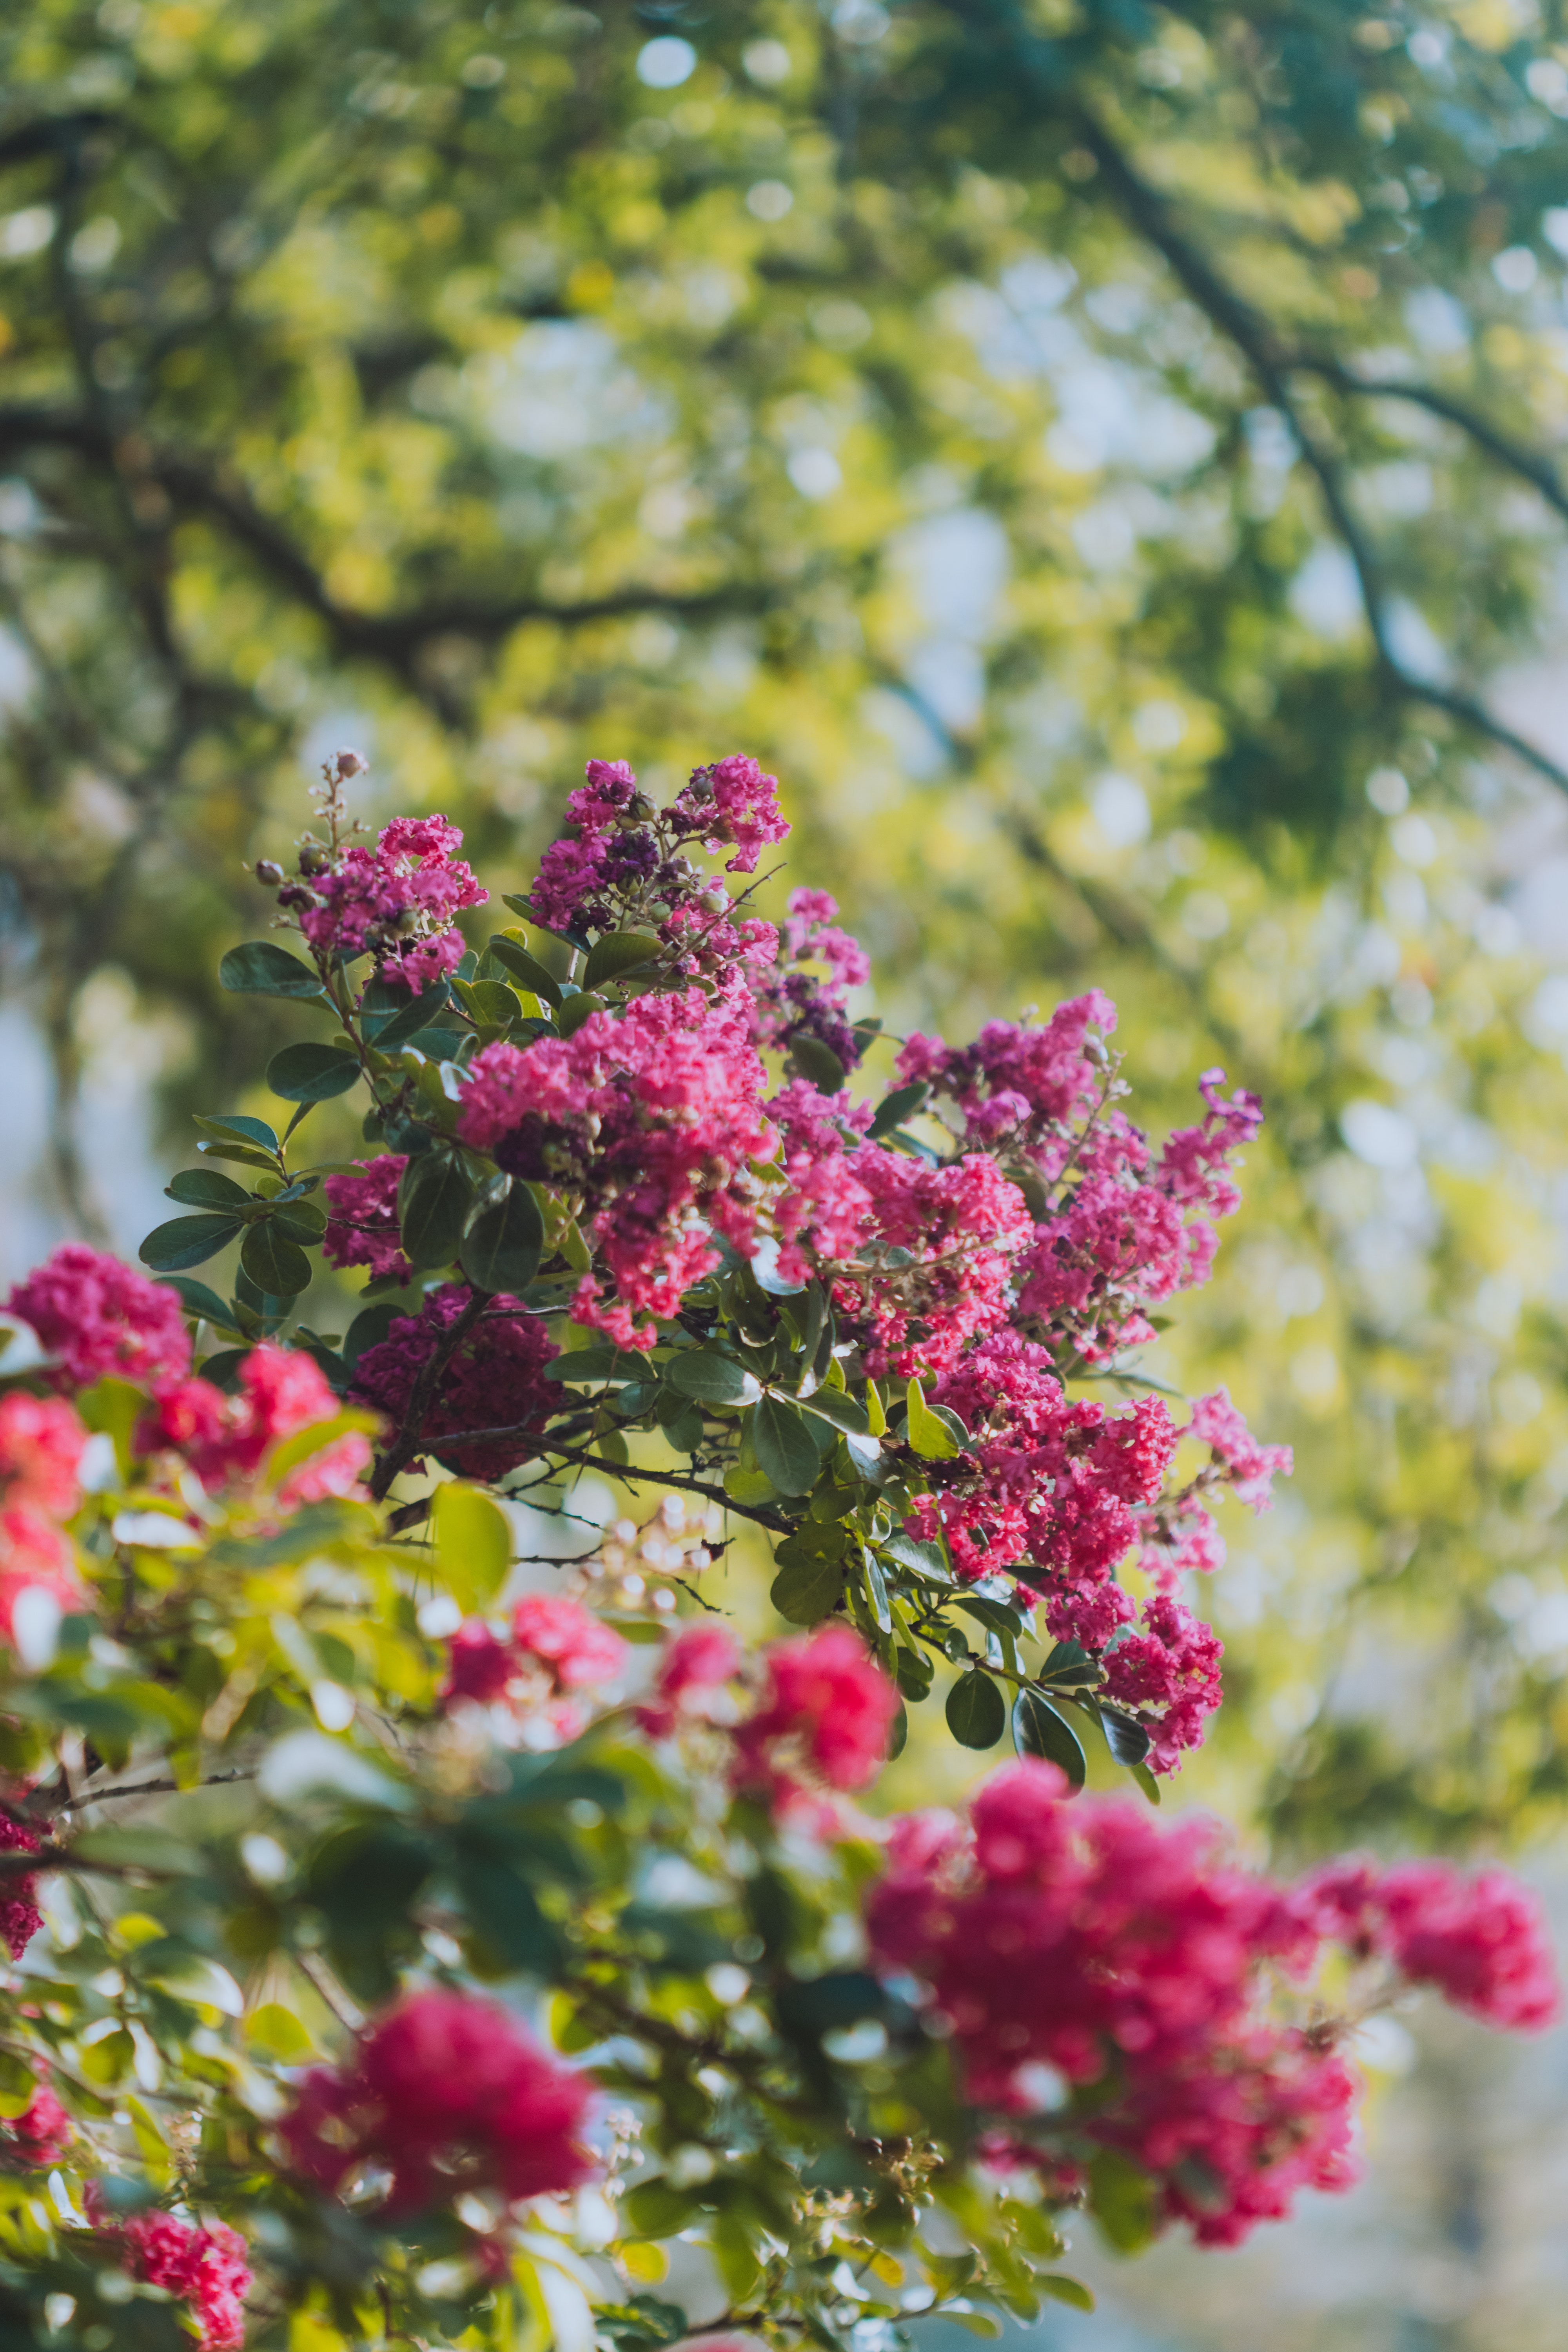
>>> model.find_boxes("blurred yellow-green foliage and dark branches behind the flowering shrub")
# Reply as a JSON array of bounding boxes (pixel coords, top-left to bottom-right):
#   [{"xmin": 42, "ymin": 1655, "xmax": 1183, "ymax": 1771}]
[{"xmin": 0, "ymin": 0, "xmax": 1568, "ymax": 2352}]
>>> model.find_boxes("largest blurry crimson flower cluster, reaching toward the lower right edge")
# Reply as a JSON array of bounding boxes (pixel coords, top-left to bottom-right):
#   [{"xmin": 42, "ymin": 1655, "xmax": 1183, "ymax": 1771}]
[{"xmin": 867, "ymin": 1762, "xmax": 1556, "ymax": 2246}]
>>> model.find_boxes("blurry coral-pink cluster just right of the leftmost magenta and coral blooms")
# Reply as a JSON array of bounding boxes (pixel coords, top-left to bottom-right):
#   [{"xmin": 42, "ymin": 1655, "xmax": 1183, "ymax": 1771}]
[{"xmin": 136, "ymin": 1341, "xmax": 372, "ymax": 1508}]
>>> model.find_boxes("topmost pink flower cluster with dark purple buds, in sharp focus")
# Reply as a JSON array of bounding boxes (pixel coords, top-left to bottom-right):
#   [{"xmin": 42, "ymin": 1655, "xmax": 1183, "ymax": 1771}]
[{"xmin": 529, "ymin": 753, "xmax": 790, "ymax": 941}]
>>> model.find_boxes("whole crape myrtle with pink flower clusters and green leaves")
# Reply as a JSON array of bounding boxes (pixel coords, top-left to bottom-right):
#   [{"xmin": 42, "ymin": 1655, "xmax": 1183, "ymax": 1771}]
[{"xmin": 0, "ymin": 753, "xmax": 1556, "ymax": 2352}]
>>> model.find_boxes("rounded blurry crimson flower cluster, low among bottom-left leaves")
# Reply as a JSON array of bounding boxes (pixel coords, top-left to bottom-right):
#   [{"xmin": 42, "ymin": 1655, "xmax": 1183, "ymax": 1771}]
[{"xmin": 282, "ymin": 1992, "xmax": 592, "ymax": 2218}]
